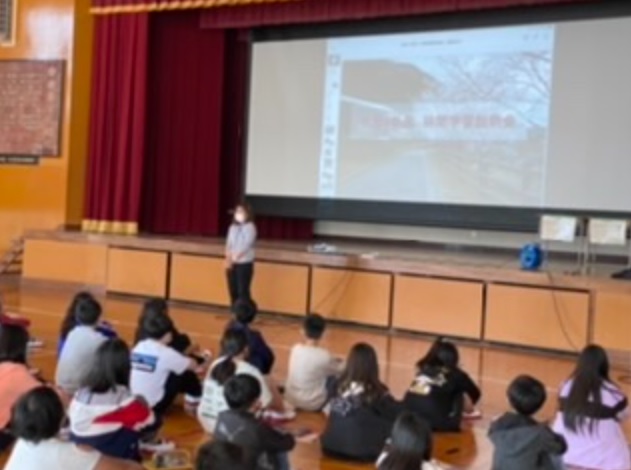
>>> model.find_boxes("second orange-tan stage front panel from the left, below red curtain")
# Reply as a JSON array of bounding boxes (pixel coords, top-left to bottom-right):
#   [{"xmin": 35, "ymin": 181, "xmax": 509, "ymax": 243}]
[{"xmin": 107, "ymin": 248, "xmax": 169, "ymax": 297}]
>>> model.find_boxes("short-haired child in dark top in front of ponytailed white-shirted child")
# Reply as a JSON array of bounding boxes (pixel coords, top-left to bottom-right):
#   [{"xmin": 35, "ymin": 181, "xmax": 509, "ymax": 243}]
[{"xmin": 215, "ymin": 374, "xmax": 296, "ymax": 470}]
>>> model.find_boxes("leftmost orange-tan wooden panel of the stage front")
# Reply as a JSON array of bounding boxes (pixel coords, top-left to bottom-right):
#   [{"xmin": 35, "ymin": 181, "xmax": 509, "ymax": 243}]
[{"xmin": 22, "ymin": 239, "xmax": 108, "ymax": 286}]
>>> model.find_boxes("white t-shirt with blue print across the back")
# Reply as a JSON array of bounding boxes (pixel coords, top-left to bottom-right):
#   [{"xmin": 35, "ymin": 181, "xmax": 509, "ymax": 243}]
[{"xmin": 129, "ymin": 339, "xmax": 191, "ymax": 408}]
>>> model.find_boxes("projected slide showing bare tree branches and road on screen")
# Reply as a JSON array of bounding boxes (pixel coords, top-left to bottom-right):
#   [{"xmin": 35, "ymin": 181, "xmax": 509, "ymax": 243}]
[{"xmin": 317, "ymin": 25, "xmax": 555, "ymax": 207}]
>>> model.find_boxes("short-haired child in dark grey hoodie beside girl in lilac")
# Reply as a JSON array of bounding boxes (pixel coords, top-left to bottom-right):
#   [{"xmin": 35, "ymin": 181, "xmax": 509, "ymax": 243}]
[{"xmin": 489, "ymin": 375, "xmax": 567, "ymax": 470}]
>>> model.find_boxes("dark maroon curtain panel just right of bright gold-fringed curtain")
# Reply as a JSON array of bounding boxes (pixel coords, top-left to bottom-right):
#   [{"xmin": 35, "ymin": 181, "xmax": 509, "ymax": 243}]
[{"xmin": 142, "ymin": 11, "xmax": 226, "ymax": 235}]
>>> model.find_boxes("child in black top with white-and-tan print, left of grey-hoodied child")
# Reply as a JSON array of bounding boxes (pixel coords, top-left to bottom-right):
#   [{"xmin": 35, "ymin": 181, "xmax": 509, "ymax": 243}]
[{"xmin": 403, "ymin": 338, "xmax": 481, "ymax": 432}]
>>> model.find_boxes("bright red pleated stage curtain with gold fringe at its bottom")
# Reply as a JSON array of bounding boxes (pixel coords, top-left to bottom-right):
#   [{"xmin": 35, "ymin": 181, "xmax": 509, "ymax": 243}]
[{"xmin": 83, "ymin": 13, "xmax": 149, "ymax": 234}]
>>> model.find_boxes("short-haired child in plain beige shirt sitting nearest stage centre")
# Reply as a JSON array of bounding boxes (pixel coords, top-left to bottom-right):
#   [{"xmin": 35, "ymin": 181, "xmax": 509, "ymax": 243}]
[{"xmin": 285, "ymin": 314, "xmax": 344, "ymax": 411}]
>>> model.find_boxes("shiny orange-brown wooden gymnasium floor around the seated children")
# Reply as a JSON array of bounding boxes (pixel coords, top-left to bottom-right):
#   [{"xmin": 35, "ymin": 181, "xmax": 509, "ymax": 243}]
[{"xmin": 0, "ymin": 279, "xmax": 631, "ymax": 470}]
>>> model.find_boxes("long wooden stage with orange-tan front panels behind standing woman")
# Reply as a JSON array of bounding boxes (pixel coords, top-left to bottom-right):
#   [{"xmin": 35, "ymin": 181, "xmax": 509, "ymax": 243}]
[{"xmin": 23, "ymin": 231, "xmax": 631, "ymax": 353}]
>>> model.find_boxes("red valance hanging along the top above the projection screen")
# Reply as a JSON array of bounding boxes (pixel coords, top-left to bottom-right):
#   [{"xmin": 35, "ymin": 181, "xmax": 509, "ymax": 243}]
[{"xmin": 202, "ymin": 0, "xmax": 594, "ymax": 28}]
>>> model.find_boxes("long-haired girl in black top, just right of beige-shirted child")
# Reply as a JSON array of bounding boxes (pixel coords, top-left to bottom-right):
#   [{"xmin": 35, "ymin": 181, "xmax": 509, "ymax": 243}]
[{"xmin": 321, "ymin": 343, "xmax": 402, "ymax": 462}]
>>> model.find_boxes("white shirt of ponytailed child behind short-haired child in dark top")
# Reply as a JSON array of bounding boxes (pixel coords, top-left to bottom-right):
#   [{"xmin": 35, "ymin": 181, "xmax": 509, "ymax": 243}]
[{"xmin": 197, "ymin": 357, "xmax": 273, "ymax": 434}]
